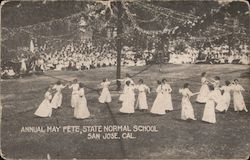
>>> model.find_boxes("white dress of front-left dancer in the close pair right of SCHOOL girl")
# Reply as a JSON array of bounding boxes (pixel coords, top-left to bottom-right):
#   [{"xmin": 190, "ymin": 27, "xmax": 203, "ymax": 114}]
[{"xmin": 150, "ymin": 85, "xmax": 166, "ymax": 115}]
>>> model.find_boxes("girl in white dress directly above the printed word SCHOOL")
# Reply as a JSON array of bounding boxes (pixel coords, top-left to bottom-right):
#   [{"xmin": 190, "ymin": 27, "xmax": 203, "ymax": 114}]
[{"xmin": 135, "ymin": 79, "xmax": 150, "ymax": 111}]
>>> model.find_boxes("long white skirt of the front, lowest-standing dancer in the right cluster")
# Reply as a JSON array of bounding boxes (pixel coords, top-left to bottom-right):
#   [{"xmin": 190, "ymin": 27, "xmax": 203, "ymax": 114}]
[{"xmin": 202, "ymin": 100, "xmax": 216, "ymax": 123}]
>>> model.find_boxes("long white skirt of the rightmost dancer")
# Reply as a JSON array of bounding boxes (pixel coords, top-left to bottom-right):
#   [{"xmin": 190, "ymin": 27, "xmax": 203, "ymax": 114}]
[{"xmin": 233, "ymin": 92, "xmax": 248, "ymax": 112}]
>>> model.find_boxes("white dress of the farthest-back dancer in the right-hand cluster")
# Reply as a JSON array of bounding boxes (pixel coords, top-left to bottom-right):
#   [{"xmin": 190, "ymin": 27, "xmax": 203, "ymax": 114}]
[{"xmin": 196, "ymin": 77, "xmax": 209, "ymax": 103}]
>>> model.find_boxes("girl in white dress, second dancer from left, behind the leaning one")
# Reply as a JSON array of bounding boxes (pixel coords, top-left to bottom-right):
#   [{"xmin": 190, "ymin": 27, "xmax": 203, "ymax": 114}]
[{"xmin": 51, "ymin": 81, "xmax": 66, "ymax": 109}]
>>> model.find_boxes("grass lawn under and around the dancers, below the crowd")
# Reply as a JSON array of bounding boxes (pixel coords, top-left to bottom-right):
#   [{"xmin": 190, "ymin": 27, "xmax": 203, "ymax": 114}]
[{"xmin": 1, "ymin": 64, "xmax": 250, "ymax": 159}]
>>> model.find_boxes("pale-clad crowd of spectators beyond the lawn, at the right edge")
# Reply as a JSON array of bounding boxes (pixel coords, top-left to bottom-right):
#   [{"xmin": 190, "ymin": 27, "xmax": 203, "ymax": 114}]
[{"xmin": 169, "ymin": 45, "xmax": 250, "ymax": 65}]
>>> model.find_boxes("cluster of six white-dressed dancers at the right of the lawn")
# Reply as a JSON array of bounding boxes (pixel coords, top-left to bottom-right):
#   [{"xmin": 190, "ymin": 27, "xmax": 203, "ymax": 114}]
[{"xmin": 179, "ymin": 72, "xmax": 248, "ymax": 123}]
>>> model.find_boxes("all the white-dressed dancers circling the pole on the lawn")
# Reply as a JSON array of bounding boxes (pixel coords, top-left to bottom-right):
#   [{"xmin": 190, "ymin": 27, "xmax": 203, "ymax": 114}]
[{"xmin": 35, "ymin": 72, "xmax": 248, "ymax": 123}]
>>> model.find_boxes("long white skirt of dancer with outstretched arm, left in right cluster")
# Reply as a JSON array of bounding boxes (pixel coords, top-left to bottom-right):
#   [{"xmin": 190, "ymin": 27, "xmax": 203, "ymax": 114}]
[{"xmin": 181, "ymin": 97, "xmax": 196, "ymax": 120}]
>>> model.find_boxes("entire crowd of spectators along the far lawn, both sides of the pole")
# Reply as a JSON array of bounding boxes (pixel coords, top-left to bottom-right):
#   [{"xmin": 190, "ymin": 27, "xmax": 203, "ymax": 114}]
[{"xmin": 1, "ymin": 41, "xmax": 250, "ymax": 78}]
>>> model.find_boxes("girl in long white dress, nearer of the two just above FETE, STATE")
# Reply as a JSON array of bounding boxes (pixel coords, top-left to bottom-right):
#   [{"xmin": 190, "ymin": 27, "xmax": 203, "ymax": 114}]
[{"xmin": 74, "ymin": 83, "xmax": 90, "ymax": 119}]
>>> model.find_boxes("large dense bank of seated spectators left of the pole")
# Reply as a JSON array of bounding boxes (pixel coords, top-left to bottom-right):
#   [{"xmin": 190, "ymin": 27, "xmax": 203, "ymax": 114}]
[{"xmin": 42, "ymin": 43, "xmax": 116, "ymax": 70}]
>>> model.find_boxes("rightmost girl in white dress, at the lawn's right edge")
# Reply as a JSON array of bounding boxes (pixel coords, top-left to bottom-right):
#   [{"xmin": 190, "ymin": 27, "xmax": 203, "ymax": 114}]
[{"xmin": 232, "ymin": 79, "xmax": 248, "ymax": 112}]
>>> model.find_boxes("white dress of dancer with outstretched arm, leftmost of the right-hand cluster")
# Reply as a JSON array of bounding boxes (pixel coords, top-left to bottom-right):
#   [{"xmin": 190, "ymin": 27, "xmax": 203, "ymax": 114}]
[{"xmin": 179, "ymin": 88, "xmax": 196, "ymax": 120}]
